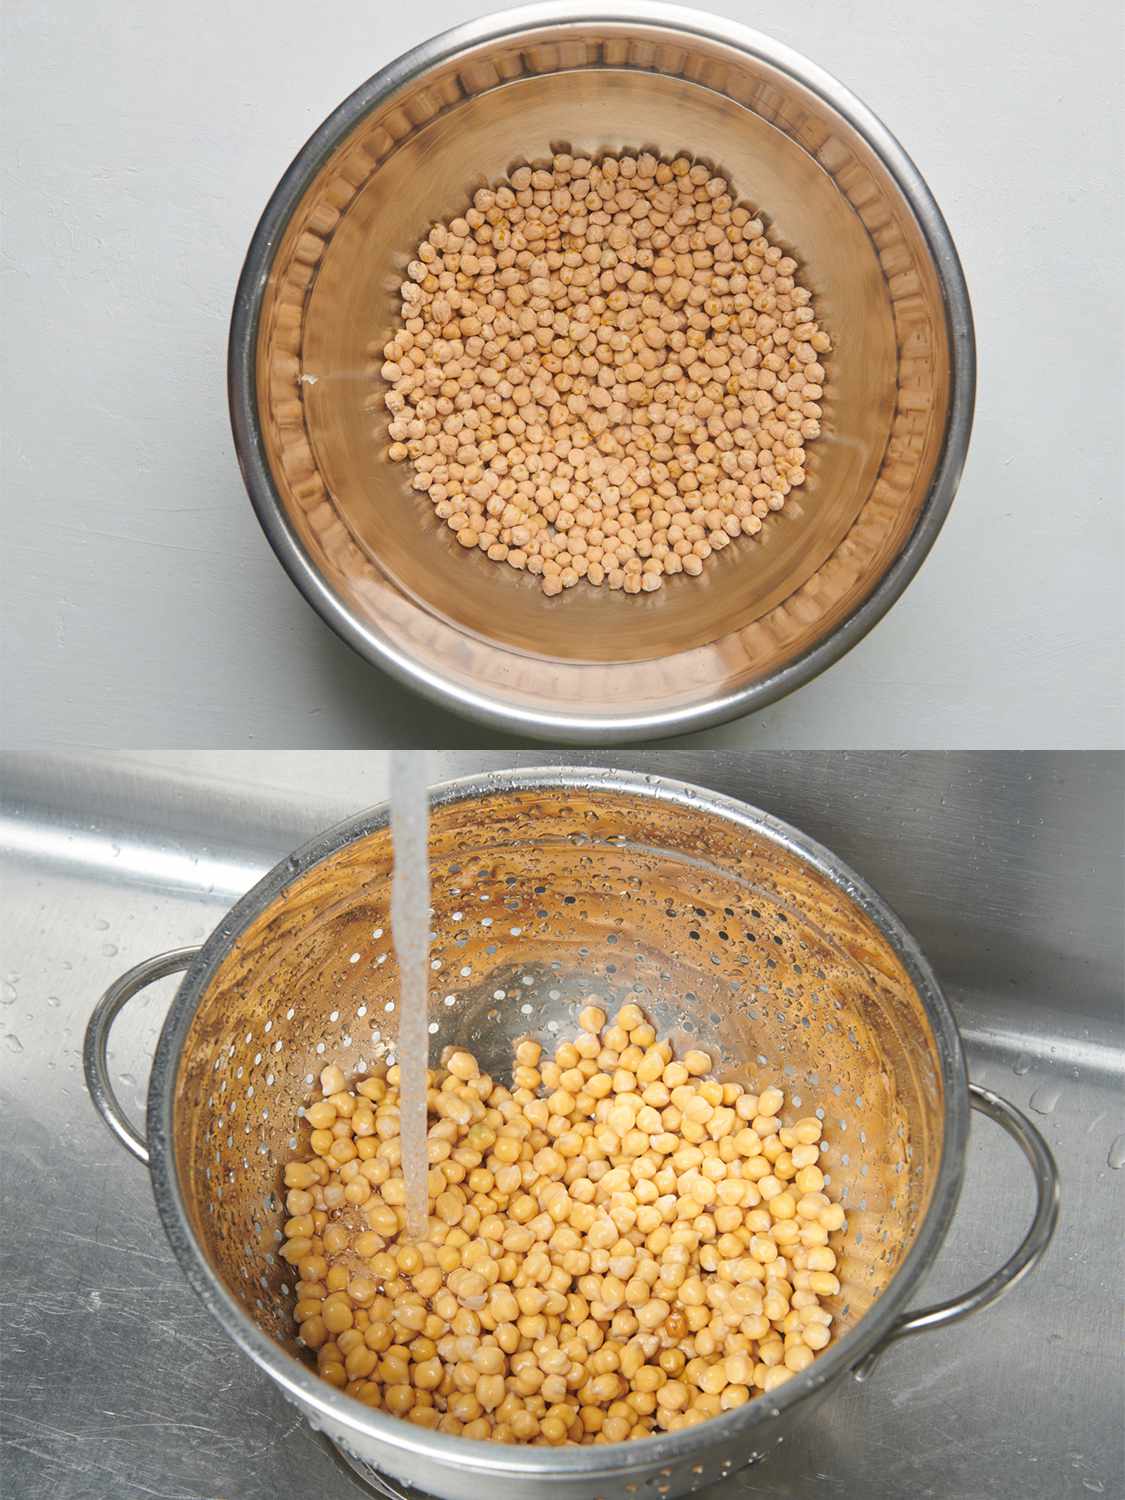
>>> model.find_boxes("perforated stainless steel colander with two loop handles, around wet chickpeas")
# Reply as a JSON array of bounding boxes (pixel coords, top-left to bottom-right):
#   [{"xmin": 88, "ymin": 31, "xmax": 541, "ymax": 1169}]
[{"xmin": 86, "ymin": 770, "xmax": 1058, "ymax": 1500}]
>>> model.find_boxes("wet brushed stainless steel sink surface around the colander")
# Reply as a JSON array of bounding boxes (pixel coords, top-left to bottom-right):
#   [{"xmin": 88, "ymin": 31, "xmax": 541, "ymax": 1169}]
[{"xmin": 0, "ymin": 752, "xmax": 1125, "ymax": 1500}]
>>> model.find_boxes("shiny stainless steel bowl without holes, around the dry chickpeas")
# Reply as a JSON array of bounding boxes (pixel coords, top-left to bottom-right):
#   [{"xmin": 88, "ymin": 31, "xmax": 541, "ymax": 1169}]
[{"xmin": 230, "ymin": 0, "xmax": 975, "ymax": 744}]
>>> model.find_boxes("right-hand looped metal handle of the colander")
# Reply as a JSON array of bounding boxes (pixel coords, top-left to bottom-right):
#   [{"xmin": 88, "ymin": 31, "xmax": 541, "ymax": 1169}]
[{"xmin": 855, "ymin": 1083, "xmax": 1059, "ymax": 1380}]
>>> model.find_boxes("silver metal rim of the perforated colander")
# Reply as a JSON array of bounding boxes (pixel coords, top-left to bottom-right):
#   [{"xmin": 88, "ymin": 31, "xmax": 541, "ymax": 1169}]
[{"xmin": 146, "ymin": 765, "xmax": 969, "ymax": 1481}]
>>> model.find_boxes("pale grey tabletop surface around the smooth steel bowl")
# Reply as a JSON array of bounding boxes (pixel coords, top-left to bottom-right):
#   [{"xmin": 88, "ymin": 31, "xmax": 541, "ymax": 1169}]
[{"xmin": 0, "ymin": 0, "xmax": 1125, "ymax": 747}]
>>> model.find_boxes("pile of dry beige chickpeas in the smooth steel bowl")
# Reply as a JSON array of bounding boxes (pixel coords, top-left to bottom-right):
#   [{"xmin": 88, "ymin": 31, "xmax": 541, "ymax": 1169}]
[{"xmin": 383, "ymin": 152, "xmax": 831, "ymax": 594}]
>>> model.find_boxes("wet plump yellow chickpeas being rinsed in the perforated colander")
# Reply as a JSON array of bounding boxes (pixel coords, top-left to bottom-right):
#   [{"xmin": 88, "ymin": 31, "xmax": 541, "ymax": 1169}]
[{"xmin": 282, "ymin": 998, "xmax": 845, "ymax": 1445}]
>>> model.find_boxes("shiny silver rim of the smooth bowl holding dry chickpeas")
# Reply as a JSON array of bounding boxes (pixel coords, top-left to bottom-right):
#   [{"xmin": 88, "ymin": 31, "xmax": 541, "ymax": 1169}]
[{"xmin": 227, "ymin": 0, "xmax": 977, "ymax": 746}]
